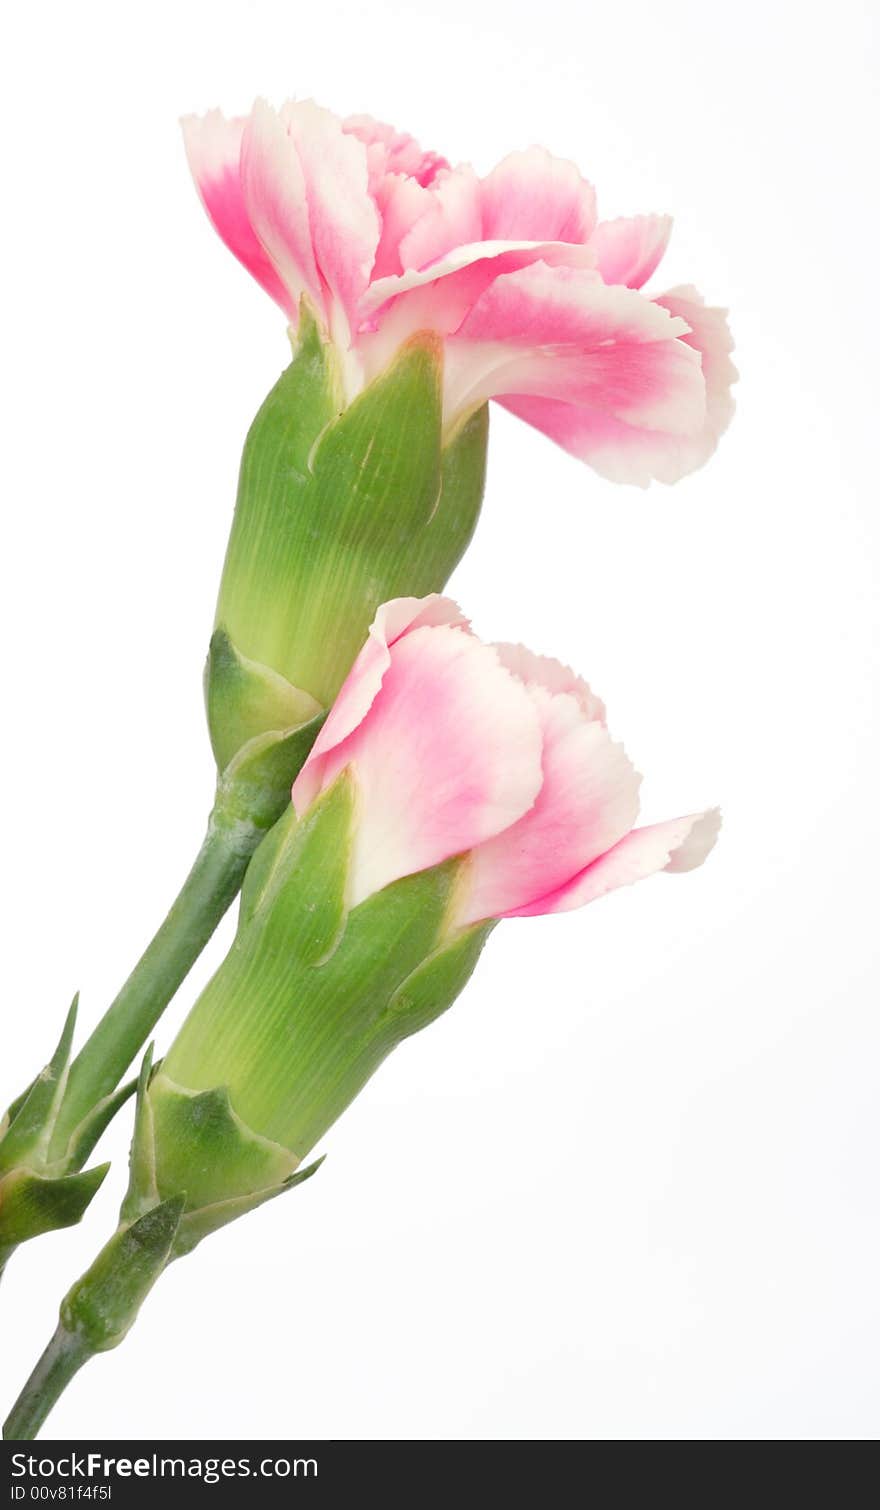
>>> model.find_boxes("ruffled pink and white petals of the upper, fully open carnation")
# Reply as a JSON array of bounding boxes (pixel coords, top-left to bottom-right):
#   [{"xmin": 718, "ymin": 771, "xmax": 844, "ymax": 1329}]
[{"xmin": 183, "ymin": 101, "xmax": 737, "ymax": 486}]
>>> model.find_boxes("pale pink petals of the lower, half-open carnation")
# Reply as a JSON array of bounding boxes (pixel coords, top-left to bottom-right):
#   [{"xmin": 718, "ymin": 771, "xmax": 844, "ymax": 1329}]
[{"xmin": 293, "ymin": 595, "xmax": 720, "ymax": 927}]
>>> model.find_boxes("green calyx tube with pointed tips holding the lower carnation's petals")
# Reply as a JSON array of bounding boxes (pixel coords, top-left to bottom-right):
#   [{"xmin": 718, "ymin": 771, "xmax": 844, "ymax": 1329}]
[{"xmin": 157, "ymin": 772, "xmax": 473, "ymax": 1153}]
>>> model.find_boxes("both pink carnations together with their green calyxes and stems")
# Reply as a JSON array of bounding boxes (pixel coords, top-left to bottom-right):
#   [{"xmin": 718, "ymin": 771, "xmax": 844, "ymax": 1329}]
[{"xmin": 0, "ymin": 101, "xmax": 737, "ymax": 1438}]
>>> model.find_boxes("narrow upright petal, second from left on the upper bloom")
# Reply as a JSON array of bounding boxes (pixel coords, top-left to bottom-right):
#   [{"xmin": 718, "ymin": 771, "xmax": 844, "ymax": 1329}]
[{"xmin": 242, "ymin": 100, "xmax": 325, "ymax": 316}]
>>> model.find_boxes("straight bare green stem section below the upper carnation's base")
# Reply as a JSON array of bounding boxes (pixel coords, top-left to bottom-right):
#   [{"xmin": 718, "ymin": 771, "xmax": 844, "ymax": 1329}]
[{"xmin": 50, "ymin": 809, "xmax": 263, "ymax": 1158}]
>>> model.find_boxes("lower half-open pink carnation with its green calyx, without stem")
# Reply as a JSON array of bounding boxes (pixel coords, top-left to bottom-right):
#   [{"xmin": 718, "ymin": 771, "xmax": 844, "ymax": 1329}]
[{"xmin": 127, "ymin": 596, "xmax": 717, "ymax": 1252}]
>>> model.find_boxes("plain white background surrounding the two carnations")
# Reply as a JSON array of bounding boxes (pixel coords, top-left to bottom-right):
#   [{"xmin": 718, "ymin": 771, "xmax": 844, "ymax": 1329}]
[{"xmin": 0, "ymin": 0, "xmax": 880, "ymax": 1439}]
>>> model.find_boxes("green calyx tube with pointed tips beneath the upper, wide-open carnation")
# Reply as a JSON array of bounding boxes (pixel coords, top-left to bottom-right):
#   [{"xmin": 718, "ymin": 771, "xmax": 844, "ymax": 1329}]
[{"xmin": 216, "ymin": 322, "xmax": 488, "ymax": 712}]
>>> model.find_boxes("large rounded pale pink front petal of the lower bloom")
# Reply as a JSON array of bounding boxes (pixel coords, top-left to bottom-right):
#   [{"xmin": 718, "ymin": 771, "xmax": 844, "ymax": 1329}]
[{"xmin": 306, "ymin": 625, "xmax": 542, "ymax": 906}]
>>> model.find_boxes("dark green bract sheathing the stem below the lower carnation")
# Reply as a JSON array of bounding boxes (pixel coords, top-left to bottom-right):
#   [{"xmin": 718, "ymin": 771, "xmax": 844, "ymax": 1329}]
[{"xmin": 60, "ymin": 1196, "xmax": 184, "ymax": 1353}]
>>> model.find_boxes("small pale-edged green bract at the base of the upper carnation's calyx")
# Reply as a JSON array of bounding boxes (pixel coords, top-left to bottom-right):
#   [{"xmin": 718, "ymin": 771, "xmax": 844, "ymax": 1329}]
[{"xmin": 205, "ymin": 625, "xmax": 322, "ymax": 773}]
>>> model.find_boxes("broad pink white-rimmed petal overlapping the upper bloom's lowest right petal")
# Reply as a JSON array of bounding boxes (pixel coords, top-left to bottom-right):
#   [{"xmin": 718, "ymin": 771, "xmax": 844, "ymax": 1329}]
[{"xmin": 444, "ymin": 263, "xmax": 705, "ymax": 435}]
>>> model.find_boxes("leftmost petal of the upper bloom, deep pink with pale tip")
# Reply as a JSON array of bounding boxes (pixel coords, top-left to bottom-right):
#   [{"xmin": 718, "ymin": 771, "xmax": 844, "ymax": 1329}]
[{"xmin": 181, "ymin": 110, "xmax": 293, "ymax": 314}]
